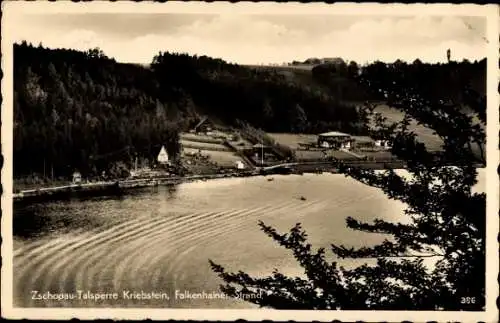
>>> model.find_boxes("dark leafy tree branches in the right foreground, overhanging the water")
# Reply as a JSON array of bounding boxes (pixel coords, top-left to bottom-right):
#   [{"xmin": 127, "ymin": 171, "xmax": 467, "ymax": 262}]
[{"xmin": 210, "ymin": 63, "xmax": 486, "ymax": 310}]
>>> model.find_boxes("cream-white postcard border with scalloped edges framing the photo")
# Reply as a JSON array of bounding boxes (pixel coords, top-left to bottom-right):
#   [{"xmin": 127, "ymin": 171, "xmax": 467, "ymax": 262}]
[{"xmin": 1, "ymin": 1, "xmax": 500, "ymax": 322}]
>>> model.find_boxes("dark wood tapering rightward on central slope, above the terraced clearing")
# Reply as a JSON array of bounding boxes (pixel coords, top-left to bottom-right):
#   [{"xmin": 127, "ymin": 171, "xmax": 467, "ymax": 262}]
[{"xmin": 151, "ymin": 53, "xmax": 366, "ymax": 133}]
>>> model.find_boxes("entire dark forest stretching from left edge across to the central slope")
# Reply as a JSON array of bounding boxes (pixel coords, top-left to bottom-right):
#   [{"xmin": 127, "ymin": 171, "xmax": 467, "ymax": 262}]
[{"xmin": 14, "ymin": 43, "xmax": 364, "ymax": 177}]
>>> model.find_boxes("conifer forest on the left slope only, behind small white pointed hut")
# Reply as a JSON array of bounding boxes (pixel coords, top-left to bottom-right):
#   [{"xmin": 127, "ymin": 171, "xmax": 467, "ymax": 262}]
[{"xmin": 14, "ymin": 44, "xmax": 184, "ymax": 176}]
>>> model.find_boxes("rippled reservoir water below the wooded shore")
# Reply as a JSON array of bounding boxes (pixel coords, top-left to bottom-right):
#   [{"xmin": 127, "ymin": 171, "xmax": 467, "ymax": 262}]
[{"xmin": 13, "ymin": 170, "xmax": 485, "ymax": 308}]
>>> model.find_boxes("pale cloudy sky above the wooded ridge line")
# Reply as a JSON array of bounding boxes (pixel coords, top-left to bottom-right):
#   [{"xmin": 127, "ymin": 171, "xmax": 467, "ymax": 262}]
[{"xmin": 10, "ymin": 12, "xmax": 487, "ymax": 64}]
